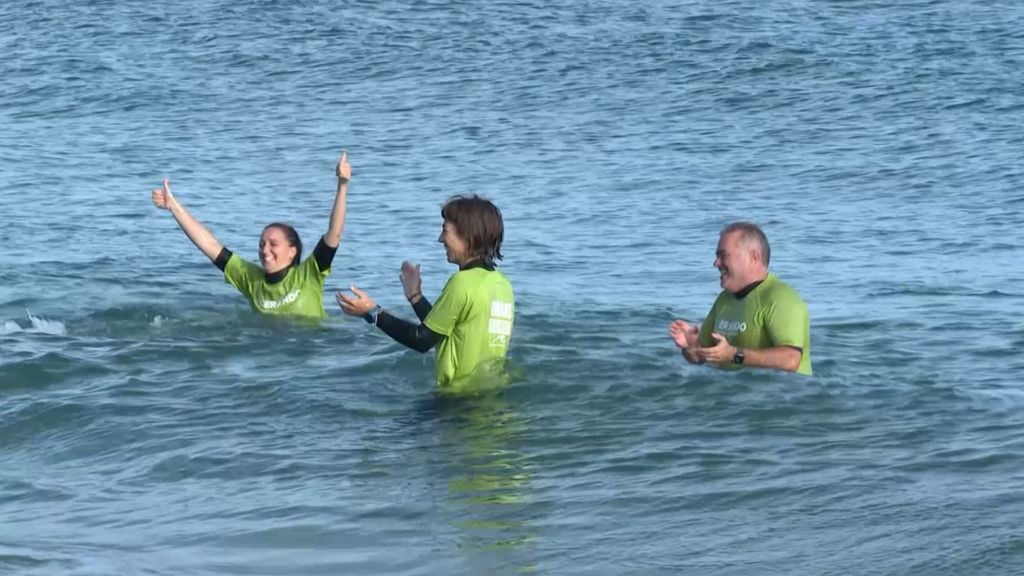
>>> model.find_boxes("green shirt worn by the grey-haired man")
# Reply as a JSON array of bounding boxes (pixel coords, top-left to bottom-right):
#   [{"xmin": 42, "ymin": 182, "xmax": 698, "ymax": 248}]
[{"xmin": 700, "ymin": 273, "xmax": 811, "ymax": 375}]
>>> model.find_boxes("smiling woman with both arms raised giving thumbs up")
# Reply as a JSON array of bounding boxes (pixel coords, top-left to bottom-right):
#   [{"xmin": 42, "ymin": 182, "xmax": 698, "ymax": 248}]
[{"xmin": 153, "ymin": 152, "xmax": 352, "ymax": 318}]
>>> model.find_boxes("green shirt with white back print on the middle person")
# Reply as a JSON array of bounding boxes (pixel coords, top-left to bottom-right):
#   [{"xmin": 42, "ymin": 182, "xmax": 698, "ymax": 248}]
[{"xmin": 423, "ymin": 268, "xmax": 515, "ymax": 387}]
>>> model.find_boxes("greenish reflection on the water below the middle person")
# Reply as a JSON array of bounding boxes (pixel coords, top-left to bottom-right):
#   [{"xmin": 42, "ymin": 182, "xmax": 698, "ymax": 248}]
[{"xmin": 436, "ymin": 390, "xmax": 535, "ymax": 572}]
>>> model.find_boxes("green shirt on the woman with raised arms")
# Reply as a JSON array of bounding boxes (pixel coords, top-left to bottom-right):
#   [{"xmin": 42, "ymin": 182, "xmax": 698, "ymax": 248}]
[{"xmin": 224, "ymin": 254, "xmax": 331, "ymax": 319}]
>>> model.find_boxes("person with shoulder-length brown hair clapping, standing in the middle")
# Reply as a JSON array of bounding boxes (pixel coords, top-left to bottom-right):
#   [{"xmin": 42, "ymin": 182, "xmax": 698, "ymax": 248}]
[{"xmin": 335, "ymin": 195, "xmax": 515, "ymax": 388}]
